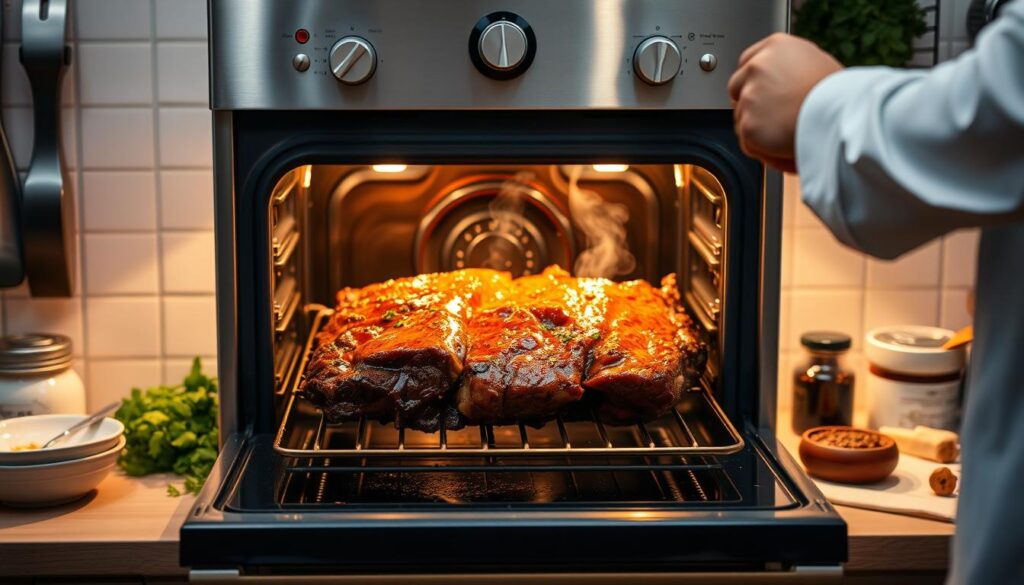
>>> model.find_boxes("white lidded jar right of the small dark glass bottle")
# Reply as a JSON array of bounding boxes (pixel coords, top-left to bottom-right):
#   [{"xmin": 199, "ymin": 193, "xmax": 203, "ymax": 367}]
[{"xmin": 864, "ymin": 325, "xmax": 966, "ymax": 430}]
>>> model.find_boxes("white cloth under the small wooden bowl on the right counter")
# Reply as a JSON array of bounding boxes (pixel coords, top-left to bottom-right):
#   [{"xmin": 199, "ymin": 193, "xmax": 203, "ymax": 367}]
[{"xmin": 814, "ymin": 453, "xmax": 961, "ymax": 523}]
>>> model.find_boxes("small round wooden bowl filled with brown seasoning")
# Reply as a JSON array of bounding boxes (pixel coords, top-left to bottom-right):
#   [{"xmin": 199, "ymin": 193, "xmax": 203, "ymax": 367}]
[{"xmin": 800, "ymin": 426, "xmax": 899, "ymax": 484}]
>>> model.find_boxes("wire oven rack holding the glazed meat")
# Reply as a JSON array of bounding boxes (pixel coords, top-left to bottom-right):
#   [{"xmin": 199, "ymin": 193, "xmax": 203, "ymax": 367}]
[{"xmin": 273, "ymin": 305, "xmax": 744, "ymax": 459}]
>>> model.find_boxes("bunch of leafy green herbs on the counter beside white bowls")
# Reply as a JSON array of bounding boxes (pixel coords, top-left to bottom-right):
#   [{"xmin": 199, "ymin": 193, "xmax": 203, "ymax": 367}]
[{"xmin": 114, "ymin": 358, "xmax": 217, "ymax": 496}]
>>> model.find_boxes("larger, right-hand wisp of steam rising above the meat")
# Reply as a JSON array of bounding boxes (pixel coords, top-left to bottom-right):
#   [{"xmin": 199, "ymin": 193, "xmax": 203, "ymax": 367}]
[{"xmin": 568, "ymin": 165, "xmax": 636, "ymax": 278}]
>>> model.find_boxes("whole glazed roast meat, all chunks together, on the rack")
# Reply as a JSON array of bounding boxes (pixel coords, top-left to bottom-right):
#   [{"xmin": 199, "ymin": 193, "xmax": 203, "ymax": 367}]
[{"xmin": 299, "ymin": 266, "xmax": 707, "ymax": 431}]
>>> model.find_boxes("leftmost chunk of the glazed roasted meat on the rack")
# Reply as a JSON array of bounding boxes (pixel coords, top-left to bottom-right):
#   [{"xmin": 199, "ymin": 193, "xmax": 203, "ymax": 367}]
[{"xmin": 299, "ymin": 270, "xmax": 510, "ymax": 431}]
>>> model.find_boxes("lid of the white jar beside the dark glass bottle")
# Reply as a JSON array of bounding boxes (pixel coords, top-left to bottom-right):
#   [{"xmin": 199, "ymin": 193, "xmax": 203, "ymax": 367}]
[{"xmin": 864, "ymin": 325, "xmax": 966, "ymax": 375}]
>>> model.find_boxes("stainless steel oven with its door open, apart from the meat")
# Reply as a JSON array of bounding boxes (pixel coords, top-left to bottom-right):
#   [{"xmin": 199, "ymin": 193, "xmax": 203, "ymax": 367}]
[{"xmin": 181, "ymin": 0, "xmax": 847, "ymax": 583}]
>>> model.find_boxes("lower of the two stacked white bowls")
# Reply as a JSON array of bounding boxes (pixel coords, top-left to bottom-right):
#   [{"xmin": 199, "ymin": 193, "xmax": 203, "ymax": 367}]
[{"xmin": 0, "ymin": 436, "xmax": 127, "ymax": 507}]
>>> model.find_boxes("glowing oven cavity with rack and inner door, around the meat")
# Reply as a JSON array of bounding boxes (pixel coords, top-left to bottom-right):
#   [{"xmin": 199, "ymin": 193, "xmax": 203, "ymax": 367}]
[{"xmin": 232, "ymin": 163, "xmax": 800, "ymax": 511}]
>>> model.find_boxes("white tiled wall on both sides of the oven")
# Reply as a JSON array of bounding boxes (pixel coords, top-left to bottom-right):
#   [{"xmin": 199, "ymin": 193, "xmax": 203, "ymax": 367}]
[{"xmin": 0, "ymin": 0, "xmax": 977, "ymax": 406}]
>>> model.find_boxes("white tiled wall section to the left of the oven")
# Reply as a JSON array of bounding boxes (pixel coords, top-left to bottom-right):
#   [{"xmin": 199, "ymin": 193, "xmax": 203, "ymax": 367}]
[{"xmin": 0, "ymin": 0, "xmax": 216, "ymax": 407}]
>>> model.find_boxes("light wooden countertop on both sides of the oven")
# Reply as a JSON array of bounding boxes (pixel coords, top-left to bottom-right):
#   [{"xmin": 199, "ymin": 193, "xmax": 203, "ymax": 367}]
[{"xmin": 0, "ymin": 436, "xmax": 953, "ymax": 578}]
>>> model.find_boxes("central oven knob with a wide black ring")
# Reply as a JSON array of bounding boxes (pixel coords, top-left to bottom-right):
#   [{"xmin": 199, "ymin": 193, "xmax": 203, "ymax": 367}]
[{"xmin": 469, "ymin": 12, "xmax": 537, "ymax": 80}]
